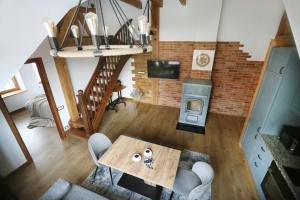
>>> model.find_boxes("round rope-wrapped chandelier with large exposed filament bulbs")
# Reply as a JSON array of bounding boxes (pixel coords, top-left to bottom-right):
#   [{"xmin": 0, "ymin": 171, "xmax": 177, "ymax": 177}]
[{"xmin": 44, "ymin": 0, "xmax": 152, "ymax": 58}]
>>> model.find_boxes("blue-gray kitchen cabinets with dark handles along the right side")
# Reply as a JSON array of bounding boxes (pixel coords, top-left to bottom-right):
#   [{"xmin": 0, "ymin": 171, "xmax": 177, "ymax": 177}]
[{"xmin": 242, "ymin": 47, "xmax": 300, "ymax": 199}]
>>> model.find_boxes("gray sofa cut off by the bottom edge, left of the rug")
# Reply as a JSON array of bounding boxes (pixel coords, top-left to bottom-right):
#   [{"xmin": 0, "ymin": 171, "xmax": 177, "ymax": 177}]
[{"xmin": 39, "ymin": 179, "xmax": 108, "ymax": 200}]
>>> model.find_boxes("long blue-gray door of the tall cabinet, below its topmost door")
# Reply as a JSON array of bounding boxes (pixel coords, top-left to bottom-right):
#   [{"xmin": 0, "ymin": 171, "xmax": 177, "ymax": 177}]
[{"xmin": 242, "ymin": 70, "xmax": 282, "ymax": 161}]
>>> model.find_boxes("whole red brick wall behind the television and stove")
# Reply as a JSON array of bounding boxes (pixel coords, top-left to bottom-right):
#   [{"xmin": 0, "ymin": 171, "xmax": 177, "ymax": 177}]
[{"xmin": 158, "ymin": 42, "xmax": 263, "ymax": 116}]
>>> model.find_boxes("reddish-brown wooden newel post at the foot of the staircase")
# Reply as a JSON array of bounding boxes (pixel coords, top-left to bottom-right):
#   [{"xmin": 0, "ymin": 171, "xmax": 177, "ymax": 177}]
[{"xmin": 77, "ymin": 90, "xmax": 94, "ymax": 136}]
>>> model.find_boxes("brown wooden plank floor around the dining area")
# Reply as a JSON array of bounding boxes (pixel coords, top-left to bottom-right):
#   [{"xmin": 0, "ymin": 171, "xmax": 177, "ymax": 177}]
[{"xmin": 7, "ymin": 102, "xmax": 257, "ymax": 200}]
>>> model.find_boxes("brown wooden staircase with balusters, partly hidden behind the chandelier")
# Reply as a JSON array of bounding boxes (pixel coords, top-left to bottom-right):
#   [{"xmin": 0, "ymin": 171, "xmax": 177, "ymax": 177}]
[{"xmin": 69, "ymin": 20, "xmax": 132, "ymax": 137}]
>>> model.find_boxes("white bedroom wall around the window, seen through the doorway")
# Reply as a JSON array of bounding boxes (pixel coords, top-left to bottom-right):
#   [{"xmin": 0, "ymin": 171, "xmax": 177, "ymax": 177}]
[{"xmin": 4, "ymin": 64, "xmax": 44, "ymax": 112}]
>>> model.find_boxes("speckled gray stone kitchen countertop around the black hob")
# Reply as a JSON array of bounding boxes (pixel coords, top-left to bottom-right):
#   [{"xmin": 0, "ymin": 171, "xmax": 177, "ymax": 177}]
[{"xmin": 262, "ymin": 134, "xmax": 300, "ymax": 199}]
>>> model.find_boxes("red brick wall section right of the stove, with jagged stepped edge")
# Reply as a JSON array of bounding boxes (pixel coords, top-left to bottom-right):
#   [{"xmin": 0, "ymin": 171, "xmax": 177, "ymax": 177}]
[{"xmin": 210, "ymin": 42, "xmax": 263, "ymax": 116}]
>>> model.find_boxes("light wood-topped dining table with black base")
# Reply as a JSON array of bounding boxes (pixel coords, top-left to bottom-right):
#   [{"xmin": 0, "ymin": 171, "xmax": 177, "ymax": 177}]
[{"xmin": 98, "ymin": 135, "xmax": 181, "ymax": 199}]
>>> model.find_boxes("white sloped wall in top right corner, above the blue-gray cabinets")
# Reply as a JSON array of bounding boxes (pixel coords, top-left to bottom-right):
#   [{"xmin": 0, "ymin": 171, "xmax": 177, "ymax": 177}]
[{"xmin": 283, "ymin": 0, "xmax": 300, "ymax": 54}]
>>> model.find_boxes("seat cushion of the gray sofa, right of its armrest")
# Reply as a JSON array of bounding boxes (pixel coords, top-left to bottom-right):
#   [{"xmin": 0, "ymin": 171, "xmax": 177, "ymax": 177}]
[{"xmin": 64, "ymin": 184, "xmax": 108, "ymax": 200}]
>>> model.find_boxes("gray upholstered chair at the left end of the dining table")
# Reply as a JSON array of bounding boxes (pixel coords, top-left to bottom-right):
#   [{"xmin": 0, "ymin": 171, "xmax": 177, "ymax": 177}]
[{"xmin": 88, "ymin": 133, "xmax": 113, "ymax": 183}]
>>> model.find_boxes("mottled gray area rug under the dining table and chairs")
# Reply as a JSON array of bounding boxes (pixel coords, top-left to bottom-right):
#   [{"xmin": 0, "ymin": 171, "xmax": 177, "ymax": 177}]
[{"xmin": 81, "ymin": 150, "xmax": 211, "ymax": 200}]
